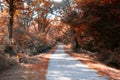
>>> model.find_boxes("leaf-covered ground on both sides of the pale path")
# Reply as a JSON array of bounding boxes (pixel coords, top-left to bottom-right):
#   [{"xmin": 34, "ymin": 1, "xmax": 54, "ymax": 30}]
[{"xmin": 0, "ymin": 45, "xmax": 120, "ymax": 80}]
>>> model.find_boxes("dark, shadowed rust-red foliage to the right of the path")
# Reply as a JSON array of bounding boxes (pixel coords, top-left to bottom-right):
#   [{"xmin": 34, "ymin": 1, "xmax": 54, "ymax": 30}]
[{"xmin": 63, "ymin": 0, "xmax": 120, "ymax": 68}]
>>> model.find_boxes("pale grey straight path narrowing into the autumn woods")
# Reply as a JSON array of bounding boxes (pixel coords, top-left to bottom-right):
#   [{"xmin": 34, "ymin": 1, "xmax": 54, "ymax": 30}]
[{"xmin": 46, "ymin": 44, "xmax": 108, "ymax": 80}]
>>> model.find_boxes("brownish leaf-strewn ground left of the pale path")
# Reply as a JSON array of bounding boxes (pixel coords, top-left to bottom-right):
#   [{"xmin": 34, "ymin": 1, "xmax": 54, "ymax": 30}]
[{"xmin": 0, "ymin": 48, "xmax": 56, "ymax": 80}]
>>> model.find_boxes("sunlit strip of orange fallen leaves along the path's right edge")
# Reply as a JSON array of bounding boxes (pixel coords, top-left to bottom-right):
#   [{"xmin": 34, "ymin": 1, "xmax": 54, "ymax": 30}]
[{"xmin": 64, "ymin": 45, "xmax": 120, "ymax": 80}]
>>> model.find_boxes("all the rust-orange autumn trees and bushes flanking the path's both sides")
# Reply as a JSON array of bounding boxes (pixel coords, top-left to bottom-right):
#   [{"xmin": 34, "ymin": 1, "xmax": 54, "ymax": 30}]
[{"xmin": 0, "ymin": 0, "xmax": 120, "ymax": 74}]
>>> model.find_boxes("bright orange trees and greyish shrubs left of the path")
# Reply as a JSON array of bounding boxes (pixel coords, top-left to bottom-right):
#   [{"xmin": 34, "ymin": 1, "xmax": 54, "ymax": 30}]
[{"xmin": 0, "ymin": 0, "xmax": 56, "ymax": 70}]
